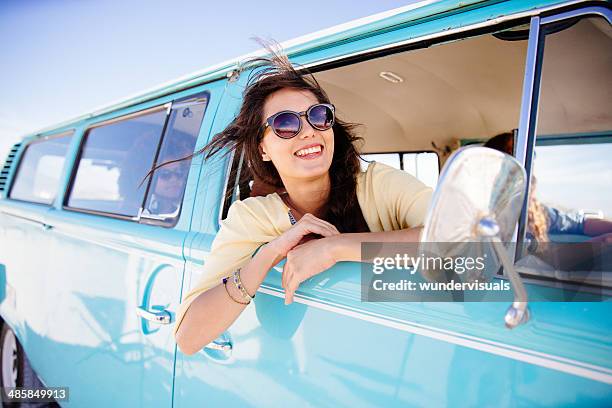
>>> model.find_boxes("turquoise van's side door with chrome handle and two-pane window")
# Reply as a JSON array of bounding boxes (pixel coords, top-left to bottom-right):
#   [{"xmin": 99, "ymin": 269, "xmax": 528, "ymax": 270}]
[{"xmin": 26, "ymin": 81, "xmax": 224, "ymax": 407}]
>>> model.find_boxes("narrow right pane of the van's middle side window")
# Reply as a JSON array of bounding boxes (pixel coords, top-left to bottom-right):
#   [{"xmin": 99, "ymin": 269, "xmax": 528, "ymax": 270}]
[{"xmin": 144, "ymin": 99, "xmax": 206, "ymax": 225}]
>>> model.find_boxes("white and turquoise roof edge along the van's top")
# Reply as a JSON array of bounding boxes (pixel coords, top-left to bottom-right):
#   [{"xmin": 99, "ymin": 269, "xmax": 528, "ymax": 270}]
[{"xmin": 24, "ymin": 0, "xmax": 585, "ymax": 139}]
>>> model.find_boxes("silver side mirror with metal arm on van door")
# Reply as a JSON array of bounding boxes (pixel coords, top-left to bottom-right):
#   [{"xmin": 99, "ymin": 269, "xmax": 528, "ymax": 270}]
[{"xmin": 419, "ymin": 147, "xmax": 529, "ymax": 328}]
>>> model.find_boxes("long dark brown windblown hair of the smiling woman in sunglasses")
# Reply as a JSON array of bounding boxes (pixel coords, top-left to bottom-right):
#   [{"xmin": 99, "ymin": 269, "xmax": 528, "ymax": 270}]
[{"xmin": 145, "ymin": 43, "xmax": 364, "ymax": 232}]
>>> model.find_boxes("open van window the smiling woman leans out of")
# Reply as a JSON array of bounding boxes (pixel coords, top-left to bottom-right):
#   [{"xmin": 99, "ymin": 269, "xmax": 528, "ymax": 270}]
[{"xmin": 222, "ymin": 26, "xmax": 527, "ymax": 217}]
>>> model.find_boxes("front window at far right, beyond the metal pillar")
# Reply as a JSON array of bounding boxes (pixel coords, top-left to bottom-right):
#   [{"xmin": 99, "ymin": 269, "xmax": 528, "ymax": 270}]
[{"xmin": 520, "ymin": 17, "xmax": 612, "ymax": 286}]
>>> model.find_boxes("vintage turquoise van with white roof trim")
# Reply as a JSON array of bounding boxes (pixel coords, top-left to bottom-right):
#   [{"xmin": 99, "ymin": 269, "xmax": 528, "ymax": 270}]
[{"xmin": 0, "ymin": 0, "xmax": 612, "ymax": 407}]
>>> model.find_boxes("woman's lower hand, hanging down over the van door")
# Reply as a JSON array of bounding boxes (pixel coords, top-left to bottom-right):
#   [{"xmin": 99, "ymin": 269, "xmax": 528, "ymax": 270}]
[{"xmin": 282, "ymin": 234, "xmax": 337, "ymax": 305}]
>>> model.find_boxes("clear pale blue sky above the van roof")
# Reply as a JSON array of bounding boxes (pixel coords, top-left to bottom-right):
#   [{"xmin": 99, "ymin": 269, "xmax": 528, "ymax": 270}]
[{"xmin": 0, "ymin": 0, "xmax": 413, "ymax": 159}]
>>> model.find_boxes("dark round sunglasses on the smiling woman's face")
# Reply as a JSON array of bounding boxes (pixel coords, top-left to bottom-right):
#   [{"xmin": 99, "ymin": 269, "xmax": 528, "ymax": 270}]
[{"xmin": 264, "ymin": 103, "xmax": 336, "ymax": 139}]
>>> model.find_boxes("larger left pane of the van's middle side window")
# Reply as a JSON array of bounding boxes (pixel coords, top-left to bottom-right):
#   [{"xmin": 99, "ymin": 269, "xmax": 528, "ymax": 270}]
[{"xmin": 67, "ymin": 110, "xmax": 166, "ymax": 216}]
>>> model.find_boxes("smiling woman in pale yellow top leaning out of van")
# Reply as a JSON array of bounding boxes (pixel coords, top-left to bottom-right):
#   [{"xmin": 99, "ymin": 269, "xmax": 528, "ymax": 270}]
[{"xmin": 174, "ymin": 49, "xmax": 432, "ymax": 354}]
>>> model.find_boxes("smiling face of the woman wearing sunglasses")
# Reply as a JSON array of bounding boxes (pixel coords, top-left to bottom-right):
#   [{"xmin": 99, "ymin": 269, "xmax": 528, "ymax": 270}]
[{"xmin": 259, "ymin": 88, "xmax": 334, "ymax": 183}]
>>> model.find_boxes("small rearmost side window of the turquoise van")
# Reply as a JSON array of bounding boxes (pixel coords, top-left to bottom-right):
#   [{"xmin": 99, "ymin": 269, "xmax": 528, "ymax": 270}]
[{"xmin": 9, "ymin": 132, "xmax": 72, "ymax": 204}]
